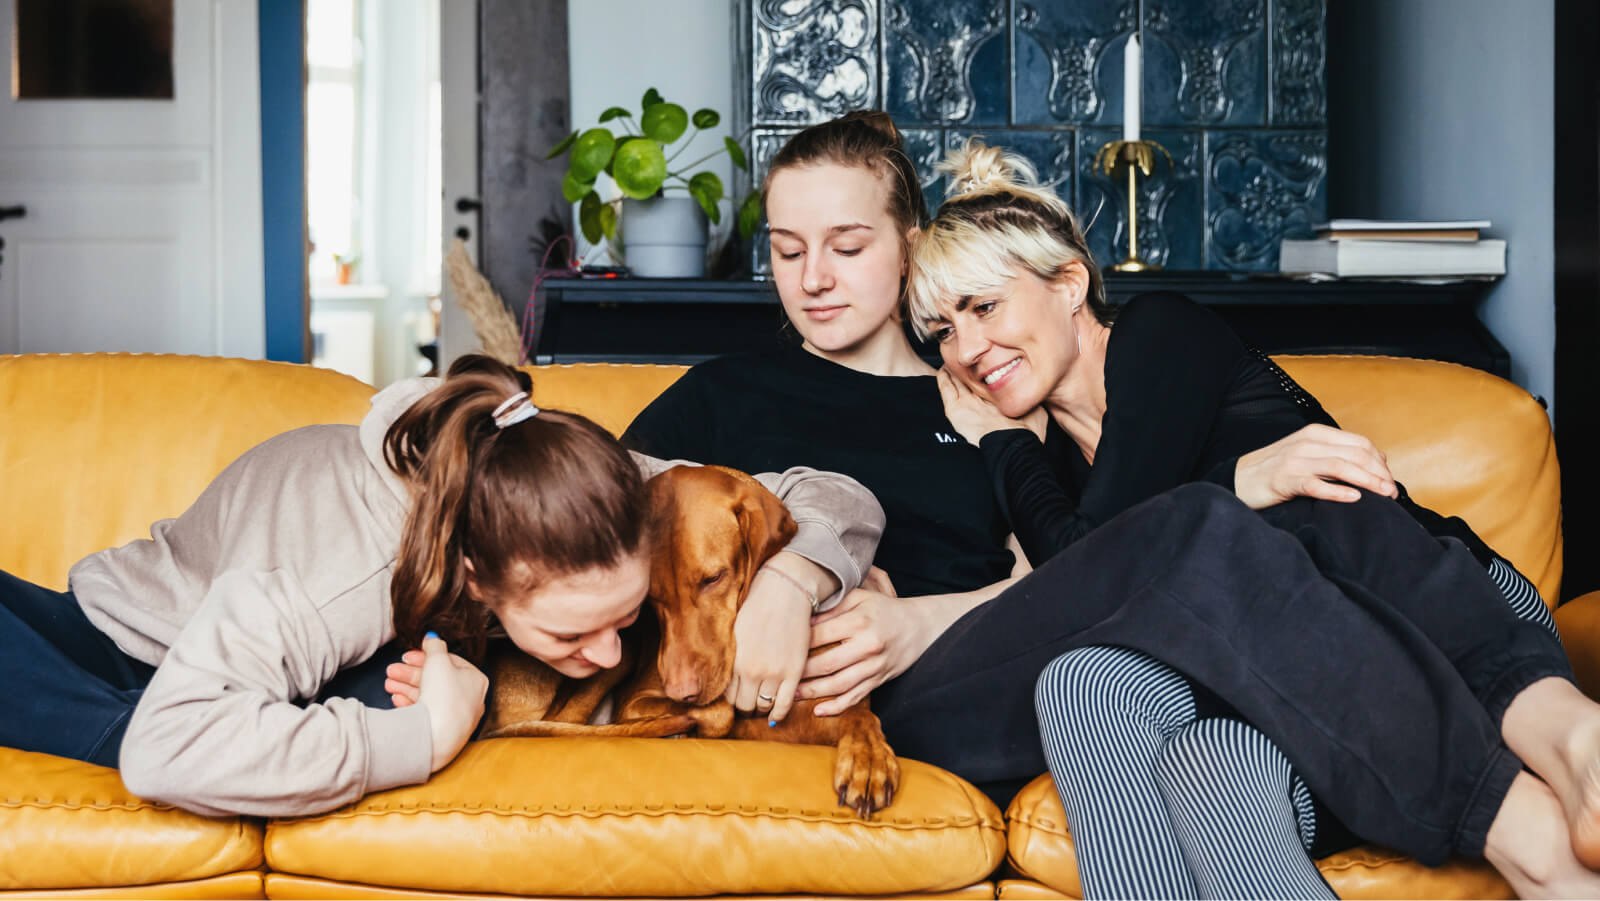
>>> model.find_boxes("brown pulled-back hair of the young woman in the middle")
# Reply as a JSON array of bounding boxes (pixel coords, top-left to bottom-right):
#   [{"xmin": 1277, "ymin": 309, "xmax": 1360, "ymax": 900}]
[{"xmin": 762, "ymin": 109, "xmax": 928, "ymax": 258}]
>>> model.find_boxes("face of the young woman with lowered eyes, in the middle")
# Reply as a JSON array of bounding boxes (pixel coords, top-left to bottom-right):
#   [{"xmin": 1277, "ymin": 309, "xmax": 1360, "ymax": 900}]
[{"xmin": 766, "ymin": 163, "xmax": 906, "ymax": 357}]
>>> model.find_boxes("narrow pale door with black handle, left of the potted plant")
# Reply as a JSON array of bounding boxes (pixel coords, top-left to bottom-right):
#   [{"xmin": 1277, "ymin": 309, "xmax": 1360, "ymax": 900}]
[{"xmin": 438, "ymin": 0, "xmax": 483, "ymax": 374}]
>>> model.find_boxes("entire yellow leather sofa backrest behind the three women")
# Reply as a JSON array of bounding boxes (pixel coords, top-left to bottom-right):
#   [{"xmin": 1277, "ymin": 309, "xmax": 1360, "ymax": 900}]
[{"xmin": 0, "ymin": 354, "xmax": 1562, "ymax": 600}]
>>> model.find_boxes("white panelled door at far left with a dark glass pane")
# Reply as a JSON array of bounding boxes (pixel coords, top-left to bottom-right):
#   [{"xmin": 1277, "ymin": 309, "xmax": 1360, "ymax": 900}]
[{"xmin": 0, "ymin": 0, "xmax": 266, "ymax": 357}]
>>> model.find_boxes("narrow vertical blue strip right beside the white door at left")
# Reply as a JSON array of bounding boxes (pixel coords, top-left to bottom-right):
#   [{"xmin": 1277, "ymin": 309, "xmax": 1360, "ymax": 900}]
[{"xmin": 259, "ymin": 0, "xmax": 307, "ymax": 363}]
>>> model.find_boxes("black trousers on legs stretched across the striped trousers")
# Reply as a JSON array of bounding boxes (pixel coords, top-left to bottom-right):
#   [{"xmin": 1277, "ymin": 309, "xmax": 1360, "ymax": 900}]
[{"xmin": 872, "ymin": 485, "xmax": 1571, "ymax": 864}]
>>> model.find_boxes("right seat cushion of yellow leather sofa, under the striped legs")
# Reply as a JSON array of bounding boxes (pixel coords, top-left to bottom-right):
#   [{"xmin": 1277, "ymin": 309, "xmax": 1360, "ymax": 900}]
[{"xmin": 1003, "ymin": 775, "xmax": 1517, "ymax": 899}]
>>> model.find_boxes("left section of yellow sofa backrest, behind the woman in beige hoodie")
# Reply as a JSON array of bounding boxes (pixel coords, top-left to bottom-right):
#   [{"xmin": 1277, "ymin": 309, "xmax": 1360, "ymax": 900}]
[{"xmin": 0, "ymin": 354, "xmax": 373, "ymax": 591}]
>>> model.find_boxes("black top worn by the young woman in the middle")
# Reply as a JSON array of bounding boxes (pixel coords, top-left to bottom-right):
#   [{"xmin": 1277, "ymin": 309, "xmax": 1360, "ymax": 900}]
[{"xmin": 622, "ymin": 347, "xmax": 1014, "ymax": 597}]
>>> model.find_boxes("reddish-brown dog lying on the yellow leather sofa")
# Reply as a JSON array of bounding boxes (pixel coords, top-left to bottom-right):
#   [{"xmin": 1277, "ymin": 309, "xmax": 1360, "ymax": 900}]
[{"xmin": 483, "ymin": 466, "xmax": 899, "ymax": 816}]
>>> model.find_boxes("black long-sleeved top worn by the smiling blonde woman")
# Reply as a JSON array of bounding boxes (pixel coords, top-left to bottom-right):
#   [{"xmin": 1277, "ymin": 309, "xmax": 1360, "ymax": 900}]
[{"xmin": 981, "ymin": 291, "xmax": 1493, "ymax": 567}]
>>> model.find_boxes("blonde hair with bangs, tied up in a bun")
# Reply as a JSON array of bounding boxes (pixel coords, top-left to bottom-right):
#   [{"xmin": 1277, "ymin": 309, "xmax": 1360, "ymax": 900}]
[{"xmin": 906, "ymin": 138, "xmax": 1114, "ymax": 341}]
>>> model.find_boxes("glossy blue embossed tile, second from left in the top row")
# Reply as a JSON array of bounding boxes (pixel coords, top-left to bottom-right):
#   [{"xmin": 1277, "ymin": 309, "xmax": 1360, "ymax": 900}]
[{"xmin": 882, "ymin": 0, "xmax": 1011, "ymax": 125}]
